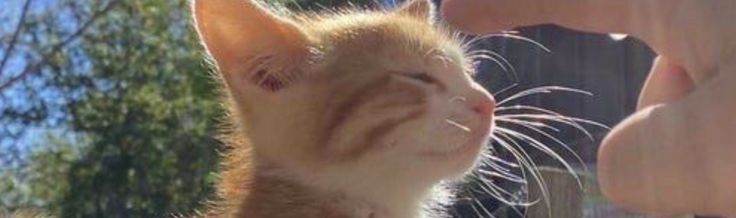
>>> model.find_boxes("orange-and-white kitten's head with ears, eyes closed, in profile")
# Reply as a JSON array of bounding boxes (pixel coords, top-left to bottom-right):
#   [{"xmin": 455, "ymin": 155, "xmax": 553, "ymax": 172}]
[{"xmin": 194, "ymin": 0, "xmax": 495, "ymax": 199}]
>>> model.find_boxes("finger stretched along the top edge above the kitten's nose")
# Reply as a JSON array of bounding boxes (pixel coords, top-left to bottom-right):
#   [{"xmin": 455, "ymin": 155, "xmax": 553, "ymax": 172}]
[{"xmin": 441, "ymin": 0, "xmax": 669, "ymax": 36}]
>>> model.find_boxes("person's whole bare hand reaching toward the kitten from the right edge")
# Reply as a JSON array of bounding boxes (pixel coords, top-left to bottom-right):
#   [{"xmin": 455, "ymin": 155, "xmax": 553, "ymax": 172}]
[{"xmin": 441, "ymin": 0, "xmax": 736, "ymax": 217}]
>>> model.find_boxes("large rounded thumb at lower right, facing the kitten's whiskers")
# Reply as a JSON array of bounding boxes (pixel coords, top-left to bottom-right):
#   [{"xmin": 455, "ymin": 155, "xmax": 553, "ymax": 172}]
[{"xmin": 598, "ymin": 67, "xmax": 736, "ymax": 215}]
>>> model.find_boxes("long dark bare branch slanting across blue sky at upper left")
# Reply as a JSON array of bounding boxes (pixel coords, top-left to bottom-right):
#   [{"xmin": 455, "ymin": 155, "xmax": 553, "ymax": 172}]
[{"xmin": 0, "ymin": 0, "xmax": 121, "ymax": 92}]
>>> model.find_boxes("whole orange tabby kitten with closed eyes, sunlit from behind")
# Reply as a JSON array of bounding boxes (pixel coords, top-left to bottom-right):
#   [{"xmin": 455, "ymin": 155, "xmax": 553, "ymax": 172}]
[{"xmin": 192, "ymin": 0, "xmax": 495, "ymax": 218}]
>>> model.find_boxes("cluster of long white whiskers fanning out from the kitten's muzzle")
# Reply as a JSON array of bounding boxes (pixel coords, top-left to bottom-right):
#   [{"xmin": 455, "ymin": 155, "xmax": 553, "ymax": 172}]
[{"xmin": 472, "ymin": 84, "xmax": 608, "ymax": 215}]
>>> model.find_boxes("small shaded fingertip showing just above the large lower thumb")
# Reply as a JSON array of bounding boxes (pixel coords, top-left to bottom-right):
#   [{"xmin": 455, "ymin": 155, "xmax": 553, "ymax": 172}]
[{"xmin": 637, "ymin": 57, "xmax": 695, "ymax": 110}]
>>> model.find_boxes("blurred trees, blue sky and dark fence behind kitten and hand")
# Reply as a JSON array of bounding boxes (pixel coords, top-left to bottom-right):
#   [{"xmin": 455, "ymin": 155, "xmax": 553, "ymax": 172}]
[{"xmin": 0, "ymin": 0, "xmax": 654, "ymax": 217}]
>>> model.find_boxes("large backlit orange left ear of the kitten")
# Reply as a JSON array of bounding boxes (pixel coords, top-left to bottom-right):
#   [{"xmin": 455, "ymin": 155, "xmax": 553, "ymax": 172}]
[{"xmin": 191, "ymin": 0, "xmax": 308, "ymax": 91}]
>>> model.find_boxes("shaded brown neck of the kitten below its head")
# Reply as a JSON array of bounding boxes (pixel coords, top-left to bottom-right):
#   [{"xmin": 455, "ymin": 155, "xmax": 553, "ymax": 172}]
[{"xmin": 223, "ymin": 153, "xmax": 436, "ymax": 218}]
